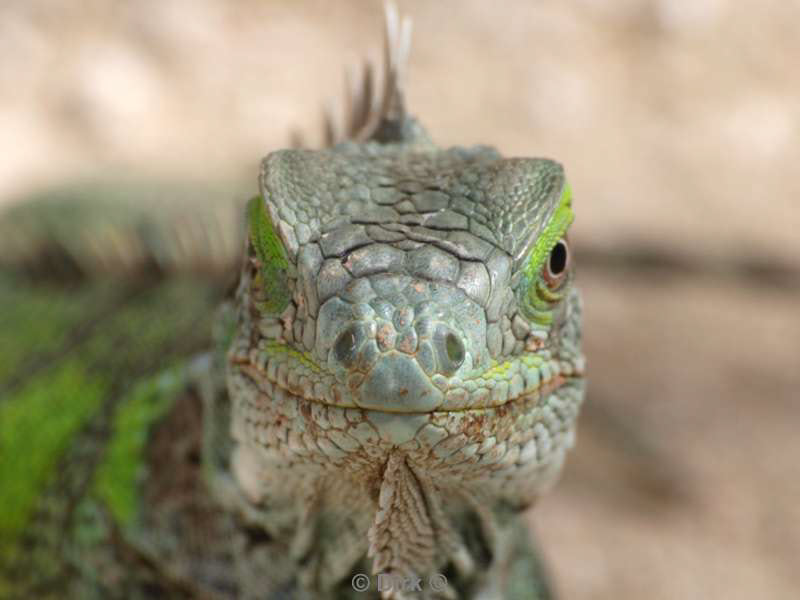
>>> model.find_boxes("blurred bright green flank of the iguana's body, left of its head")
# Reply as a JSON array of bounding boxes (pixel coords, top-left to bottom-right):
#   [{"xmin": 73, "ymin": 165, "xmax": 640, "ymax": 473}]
[{"xmin": 0, "ymin": 273, "xmax": 225, "ymax": 599}]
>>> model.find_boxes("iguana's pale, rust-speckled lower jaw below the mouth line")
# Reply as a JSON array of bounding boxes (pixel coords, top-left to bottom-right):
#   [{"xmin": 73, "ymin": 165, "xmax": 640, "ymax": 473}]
[{"xmin": 228, "ymin": 356, "xmax": 584, "ymax": 488}]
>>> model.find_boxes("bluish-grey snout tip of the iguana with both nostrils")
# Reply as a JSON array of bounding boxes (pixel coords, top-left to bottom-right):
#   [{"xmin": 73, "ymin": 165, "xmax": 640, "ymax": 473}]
[{"xmin": 315, "ymin": 273, "xmax": 489, "ymax": 413}]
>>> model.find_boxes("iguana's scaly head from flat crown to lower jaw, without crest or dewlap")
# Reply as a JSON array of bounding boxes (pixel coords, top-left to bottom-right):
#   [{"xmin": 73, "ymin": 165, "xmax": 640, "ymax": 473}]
[{"xmin": 231, "ymin": 142, "xmax": 583, "ymax": 501}]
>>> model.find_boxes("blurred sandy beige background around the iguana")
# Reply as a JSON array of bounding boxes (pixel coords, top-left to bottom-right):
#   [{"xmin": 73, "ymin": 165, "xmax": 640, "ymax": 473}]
[{"xmin": 0, "ymin": 0, "xmax": 800, "ymax": 600}]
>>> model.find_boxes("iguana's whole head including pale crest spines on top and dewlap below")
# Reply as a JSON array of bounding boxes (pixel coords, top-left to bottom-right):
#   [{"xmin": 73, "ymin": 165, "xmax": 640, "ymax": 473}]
[{"xmin": 222, "ymin": 5, "xmax": 583, "ymax": 589}]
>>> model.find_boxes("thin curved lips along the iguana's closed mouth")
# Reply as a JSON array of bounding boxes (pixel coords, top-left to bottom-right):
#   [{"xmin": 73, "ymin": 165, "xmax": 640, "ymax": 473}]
[{"xmin": 232, "ymin": 358, "xmax": 583, "ymax": 416}]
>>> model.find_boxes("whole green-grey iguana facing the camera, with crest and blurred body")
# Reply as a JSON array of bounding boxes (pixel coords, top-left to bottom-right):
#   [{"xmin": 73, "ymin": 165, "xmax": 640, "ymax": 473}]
[{"xmin": 0, "ymin": 9, "xmax": 584, "ymax": 600}]
